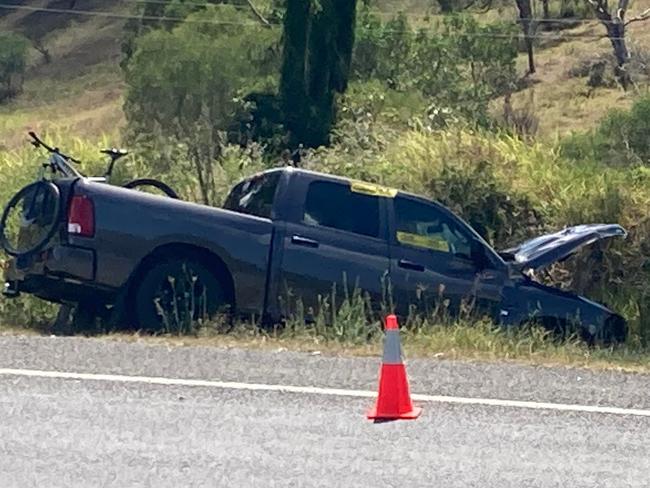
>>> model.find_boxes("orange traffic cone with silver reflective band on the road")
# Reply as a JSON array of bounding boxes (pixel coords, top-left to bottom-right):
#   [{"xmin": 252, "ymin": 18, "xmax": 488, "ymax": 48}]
[{"xmin": 368, "ymin": 315, "xmax": 422, "ymax": 420}]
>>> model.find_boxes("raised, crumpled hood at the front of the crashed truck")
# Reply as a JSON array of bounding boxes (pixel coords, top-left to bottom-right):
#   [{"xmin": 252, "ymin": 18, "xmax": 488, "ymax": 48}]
[{"xmin": 499, "ymin": 224, "xmax": 627, "ymax": 270}]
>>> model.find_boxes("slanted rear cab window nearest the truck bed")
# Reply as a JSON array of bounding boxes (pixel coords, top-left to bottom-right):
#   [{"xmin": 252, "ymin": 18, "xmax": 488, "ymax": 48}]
[{"xmin": 224, "ymin": 173, "xmax": 280, "ymax": 219}]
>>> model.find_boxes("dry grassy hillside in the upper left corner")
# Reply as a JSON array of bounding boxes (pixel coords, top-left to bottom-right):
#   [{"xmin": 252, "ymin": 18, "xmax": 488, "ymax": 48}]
[{"xmin": 0, "ymin": 0, "xmax": 130, "ymax": 148}]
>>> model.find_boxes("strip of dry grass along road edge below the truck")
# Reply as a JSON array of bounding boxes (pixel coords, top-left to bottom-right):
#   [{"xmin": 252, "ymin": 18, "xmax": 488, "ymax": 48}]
[{"xmin": 5, "ymin": 324, "xmax": 650, "ymax": 374}]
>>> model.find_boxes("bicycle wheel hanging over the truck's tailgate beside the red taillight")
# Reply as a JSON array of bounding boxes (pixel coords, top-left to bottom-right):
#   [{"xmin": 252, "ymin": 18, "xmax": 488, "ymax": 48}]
[{"xmin": 0, "ymin": 181, "xmax": 61, "ymax": 256}]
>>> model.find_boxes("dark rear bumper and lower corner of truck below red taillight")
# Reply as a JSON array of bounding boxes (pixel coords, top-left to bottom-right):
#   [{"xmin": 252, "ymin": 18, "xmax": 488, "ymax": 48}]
[{"xmin": 3, "ymin": 245, "xmax": 113, "ymax": 302}]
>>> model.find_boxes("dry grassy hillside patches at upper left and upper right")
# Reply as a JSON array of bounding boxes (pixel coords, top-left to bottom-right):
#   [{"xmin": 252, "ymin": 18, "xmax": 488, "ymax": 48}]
[{"xmin": 0, "ymin": 0, "xmax": 650, "ymax": 148}]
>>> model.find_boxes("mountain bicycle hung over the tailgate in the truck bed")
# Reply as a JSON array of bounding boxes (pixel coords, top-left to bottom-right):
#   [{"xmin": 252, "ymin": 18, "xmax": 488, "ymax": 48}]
[{"xmin": 0, "ymin": 132, "xmax": 179, "ymax": 258}]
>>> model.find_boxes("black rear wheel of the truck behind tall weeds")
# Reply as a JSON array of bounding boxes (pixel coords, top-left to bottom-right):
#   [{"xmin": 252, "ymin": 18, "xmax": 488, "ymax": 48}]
[{"xmin": 133, "ymin": 259, "xmax": 229, "ymax": 334}]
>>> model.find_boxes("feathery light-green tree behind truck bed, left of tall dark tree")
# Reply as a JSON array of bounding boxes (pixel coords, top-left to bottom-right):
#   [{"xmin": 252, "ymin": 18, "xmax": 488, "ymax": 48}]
[{"xmin": 125, "ymin": 8, "xmax": 278, "ymax": 204}]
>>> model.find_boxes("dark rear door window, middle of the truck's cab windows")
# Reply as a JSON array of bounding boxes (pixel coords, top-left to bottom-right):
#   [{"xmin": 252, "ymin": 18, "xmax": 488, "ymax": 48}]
[{"xmin": 303, "ymin": 181, "xmax": 379, "ymax": 237}]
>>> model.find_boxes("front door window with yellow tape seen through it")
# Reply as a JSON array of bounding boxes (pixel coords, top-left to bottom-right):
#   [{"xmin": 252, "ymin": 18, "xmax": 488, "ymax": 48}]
[{"xmin": 395, "ymin": 197, "xmax": 472, "ymax": 259}]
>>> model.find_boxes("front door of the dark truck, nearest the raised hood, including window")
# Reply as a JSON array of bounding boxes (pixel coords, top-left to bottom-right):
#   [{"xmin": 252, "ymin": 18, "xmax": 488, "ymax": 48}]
[{"xmin": 390, "ymin": 195, "xmax": 506, "ymax": 316}]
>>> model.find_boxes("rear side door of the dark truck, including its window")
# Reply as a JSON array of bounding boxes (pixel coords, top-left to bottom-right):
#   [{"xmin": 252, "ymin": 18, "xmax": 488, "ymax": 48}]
[{"xmin": 277, "ymin": 178, "xmax": 389, "ymax": 315}]
